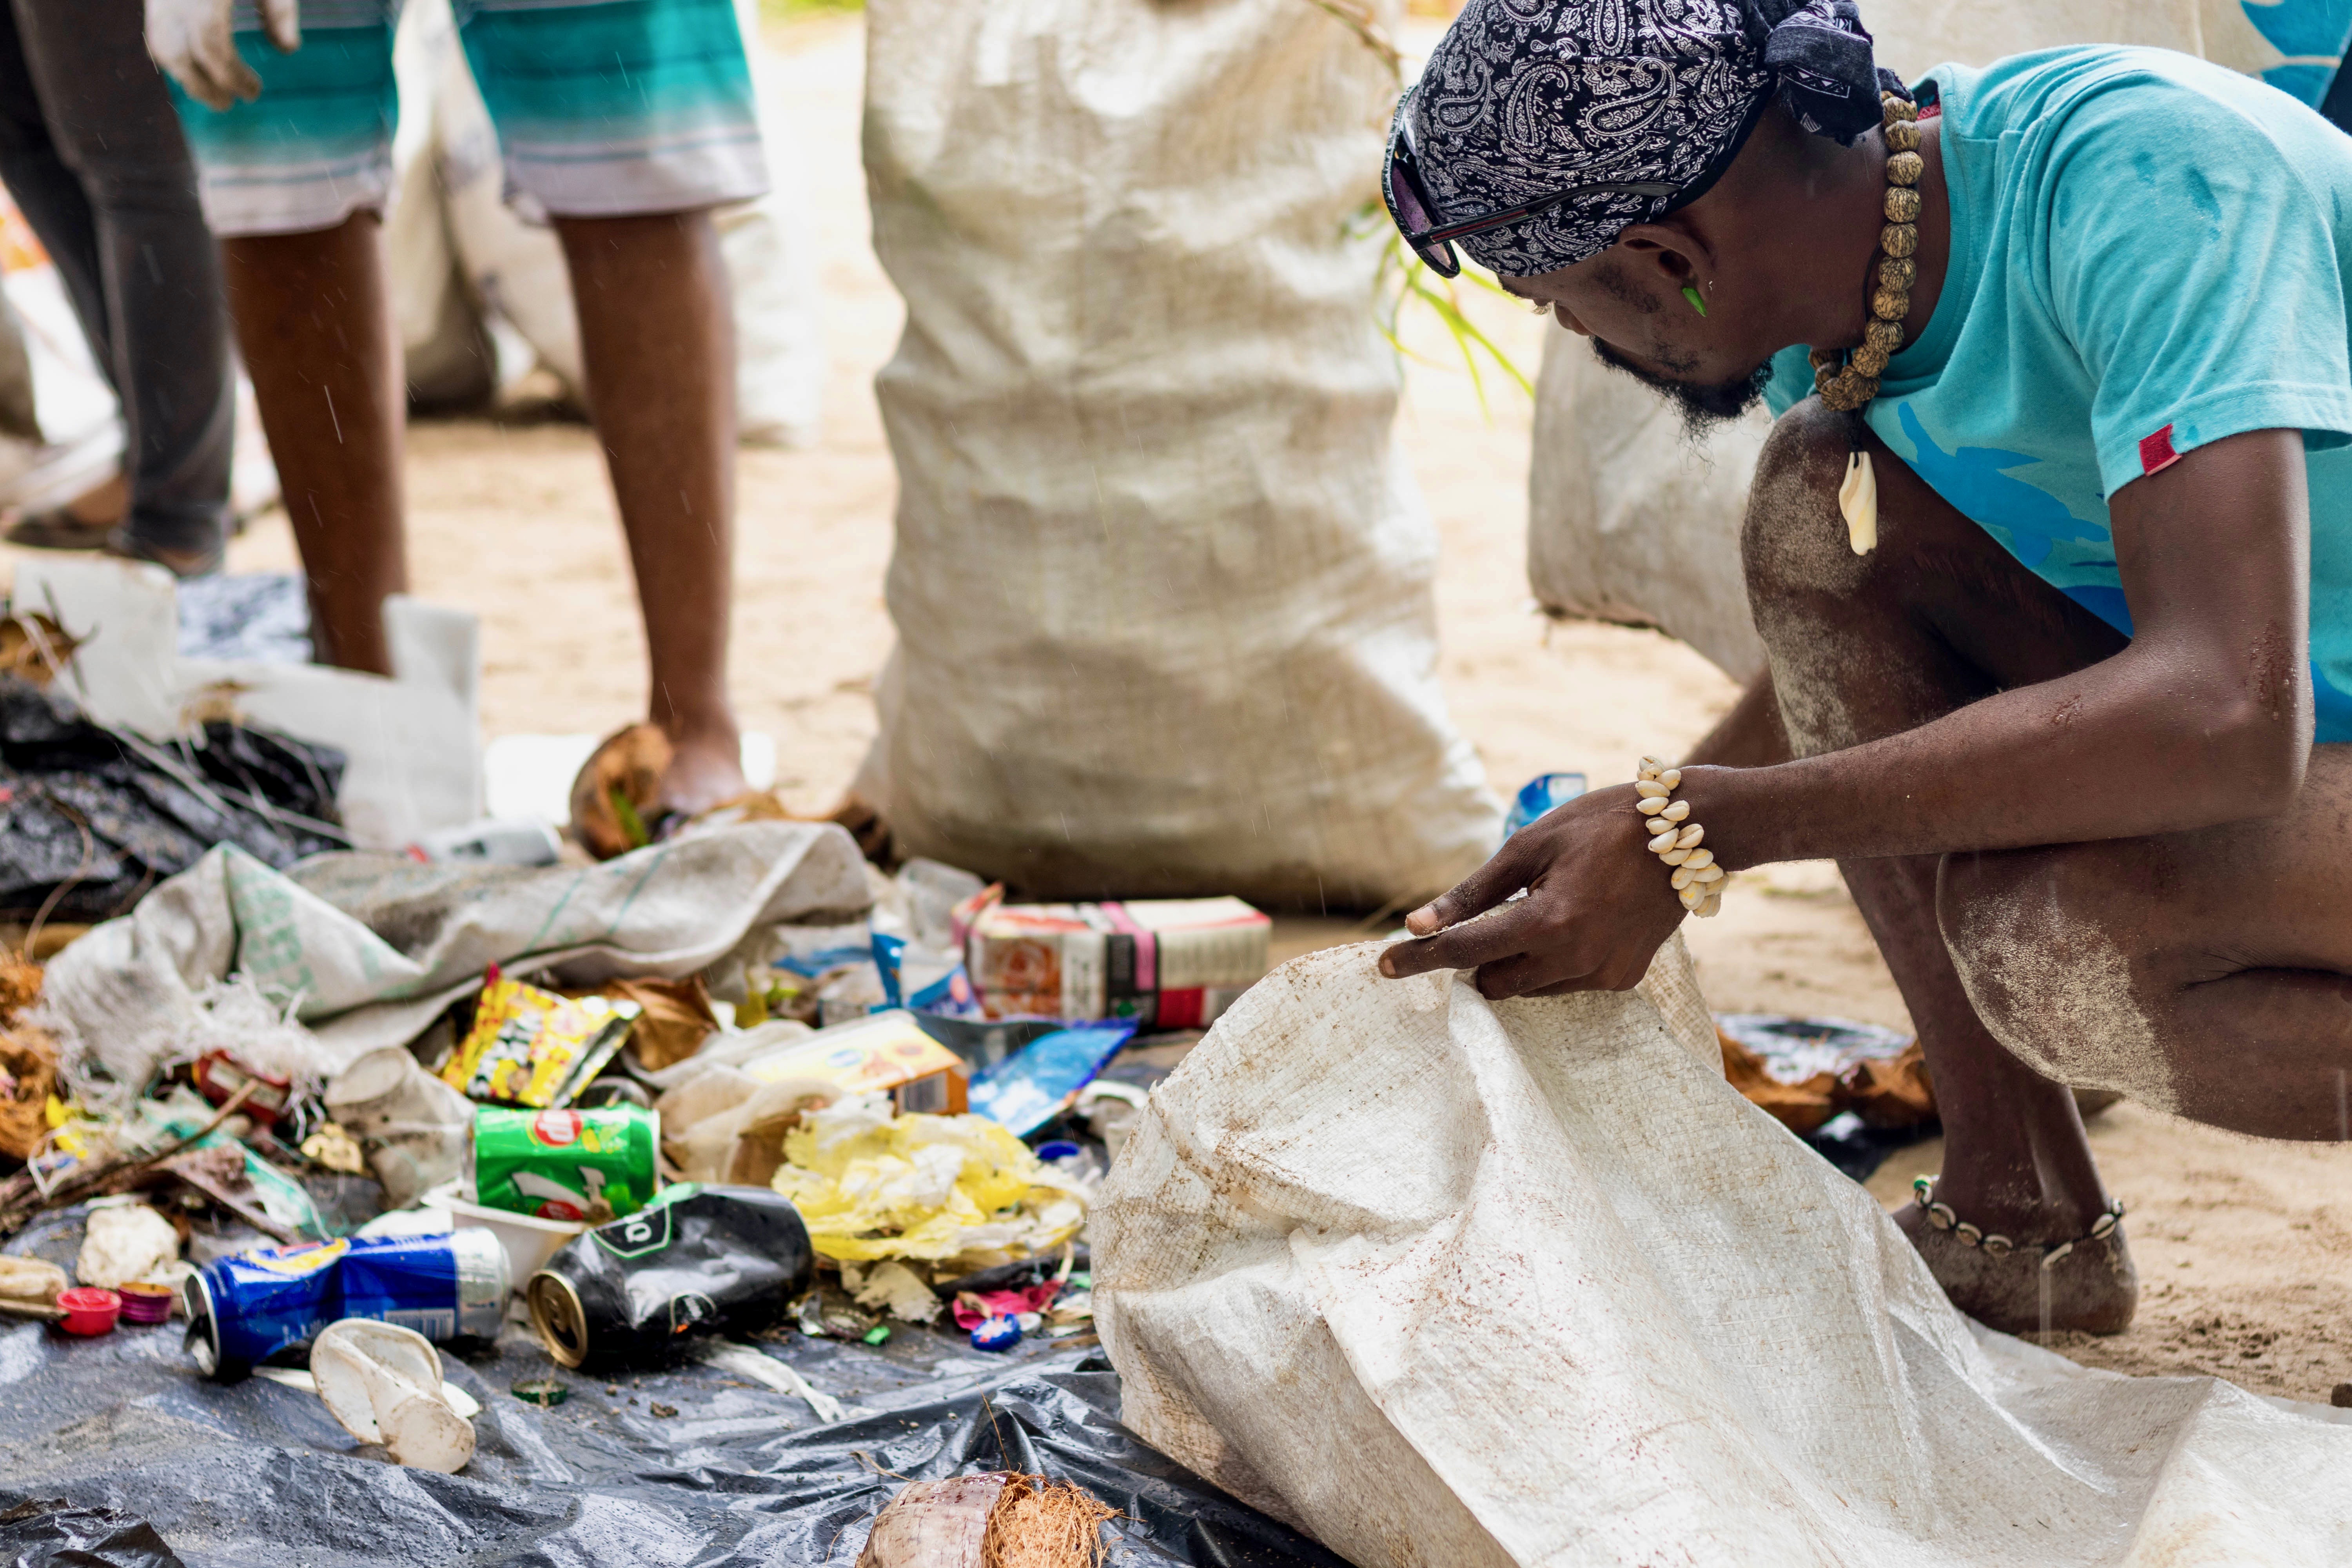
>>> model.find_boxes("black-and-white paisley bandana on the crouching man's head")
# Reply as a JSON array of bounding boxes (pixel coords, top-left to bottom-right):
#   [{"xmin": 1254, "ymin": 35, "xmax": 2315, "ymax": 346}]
[{"xmin": 1404, "ymin": 0, "xmax": 1910, "ymax": 278}]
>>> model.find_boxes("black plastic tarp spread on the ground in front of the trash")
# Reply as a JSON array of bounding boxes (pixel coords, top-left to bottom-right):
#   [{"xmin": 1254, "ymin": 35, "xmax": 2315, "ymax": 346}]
[{"xmin": 0, "ymin": 1222, "xmax": 1338, "ymax": 1568}]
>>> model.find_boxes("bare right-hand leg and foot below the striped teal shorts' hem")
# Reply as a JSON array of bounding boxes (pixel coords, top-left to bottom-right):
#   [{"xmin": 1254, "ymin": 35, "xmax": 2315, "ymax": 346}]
[{"xmin": 555, "ymin": 212, "xmax": 743, "ymax": 811}]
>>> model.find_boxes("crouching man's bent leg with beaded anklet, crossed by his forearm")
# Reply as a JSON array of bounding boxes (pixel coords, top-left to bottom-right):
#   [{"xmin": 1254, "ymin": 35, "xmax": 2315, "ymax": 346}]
[{"xmin": 1743, "ymin": 402, "xmax": 2138, "ymax": 1330}]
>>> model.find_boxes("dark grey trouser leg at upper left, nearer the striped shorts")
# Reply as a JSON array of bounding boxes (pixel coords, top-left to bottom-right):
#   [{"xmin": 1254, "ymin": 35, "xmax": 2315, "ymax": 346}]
[{"xmin": 12, "ymin": 0, "xmax": 235, "ymax": 576}]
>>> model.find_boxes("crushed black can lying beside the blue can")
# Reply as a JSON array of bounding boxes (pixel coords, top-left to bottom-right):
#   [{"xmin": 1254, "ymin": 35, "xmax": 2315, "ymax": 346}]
[{"xmin": 522, "ymin": 1182, "xmax": 816, "ymax": 1368}]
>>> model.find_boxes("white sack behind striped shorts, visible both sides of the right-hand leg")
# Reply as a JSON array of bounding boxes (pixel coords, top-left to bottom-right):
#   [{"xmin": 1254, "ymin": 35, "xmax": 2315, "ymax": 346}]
[{"xmin": 390, "ymin": 0, "xmax": 826, "ymax": 446}]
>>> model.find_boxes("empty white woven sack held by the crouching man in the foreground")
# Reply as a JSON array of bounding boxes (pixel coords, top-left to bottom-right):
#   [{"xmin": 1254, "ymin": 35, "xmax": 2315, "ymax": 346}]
[{"xmin": 1094, "ymin": 943, "xmax": 2352, "ymax": 1568}]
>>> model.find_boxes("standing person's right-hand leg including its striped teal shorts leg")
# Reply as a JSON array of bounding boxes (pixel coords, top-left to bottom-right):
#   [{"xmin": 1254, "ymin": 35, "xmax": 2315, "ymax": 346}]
[{"xmin": 463, "ymin": 0, "xmax": 767, "ymax": 811}]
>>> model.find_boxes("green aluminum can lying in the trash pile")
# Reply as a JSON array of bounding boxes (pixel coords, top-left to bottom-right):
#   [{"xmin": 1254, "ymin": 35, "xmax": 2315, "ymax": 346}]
[{"xmin": 473, "ymin": 1105, "xmax": 661, "ymax": 1225}]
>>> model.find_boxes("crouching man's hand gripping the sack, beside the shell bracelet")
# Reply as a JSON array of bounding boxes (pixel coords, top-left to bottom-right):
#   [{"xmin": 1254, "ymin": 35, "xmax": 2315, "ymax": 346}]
[{"xmin": 1381, "ymin": 785, "xmax": 1682, "ymax": 999}]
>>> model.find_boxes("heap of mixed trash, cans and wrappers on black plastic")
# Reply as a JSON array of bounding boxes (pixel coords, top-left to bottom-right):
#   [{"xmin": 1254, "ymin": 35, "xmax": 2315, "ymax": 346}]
[{"xmin": 0, "ymin": 823, "xmax": 1289, "ymax": 1561}]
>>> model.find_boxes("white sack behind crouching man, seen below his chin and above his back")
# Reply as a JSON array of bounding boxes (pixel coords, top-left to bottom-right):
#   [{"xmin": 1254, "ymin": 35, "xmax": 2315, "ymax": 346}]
[{"xmin": 1526, "ymin": 0, "xmax": 2220, "ymax": 682}]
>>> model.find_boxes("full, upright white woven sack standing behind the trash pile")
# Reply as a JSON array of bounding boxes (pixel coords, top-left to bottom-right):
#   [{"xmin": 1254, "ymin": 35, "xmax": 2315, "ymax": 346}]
[{"xmin": 858, "ymin": 0, "xmax": 1498, "ymax": 905}]
